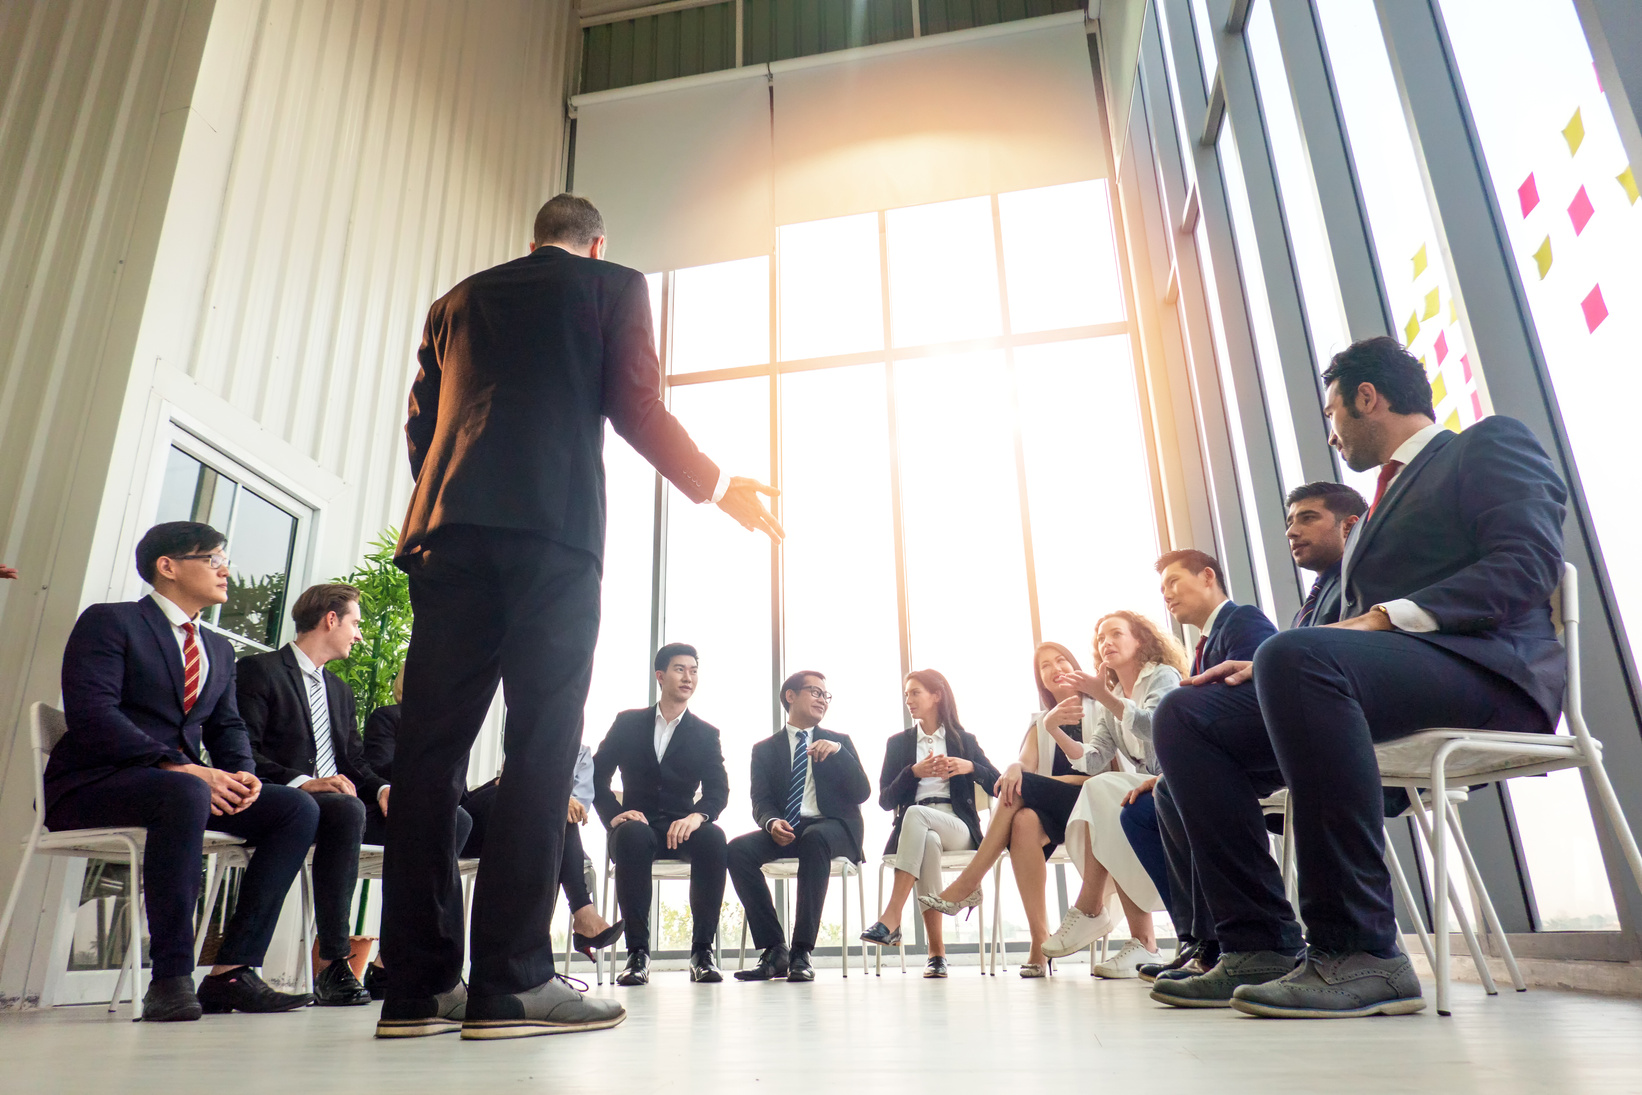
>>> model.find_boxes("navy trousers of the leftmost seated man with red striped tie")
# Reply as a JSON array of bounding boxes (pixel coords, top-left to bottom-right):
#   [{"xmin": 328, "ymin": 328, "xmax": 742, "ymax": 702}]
[{"xmin": 46, "ymin": 768, "xmax": 320, "ymax": 977}]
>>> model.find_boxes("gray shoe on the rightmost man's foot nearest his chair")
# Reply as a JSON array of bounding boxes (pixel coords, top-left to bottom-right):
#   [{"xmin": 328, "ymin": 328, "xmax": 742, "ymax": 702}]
[{"xmin": 1232, "ymin": 952, "xmax": 1425, "ymax": 1019}]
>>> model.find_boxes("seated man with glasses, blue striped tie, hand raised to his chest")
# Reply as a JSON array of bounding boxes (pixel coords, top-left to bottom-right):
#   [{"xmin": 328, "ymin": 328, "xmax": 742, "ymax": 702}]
[{"xmin": 729, "ymin": 670, "xmax": 872, "ymax": 982}]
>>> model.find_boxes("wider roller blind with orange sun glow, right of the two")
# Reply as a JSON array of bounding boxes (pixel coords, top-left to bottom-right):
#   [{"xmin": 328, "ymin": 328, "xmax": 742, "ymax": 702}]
[{"xmin": 773, "ymin": 13, "xmax": 1107, "ymax": 225}]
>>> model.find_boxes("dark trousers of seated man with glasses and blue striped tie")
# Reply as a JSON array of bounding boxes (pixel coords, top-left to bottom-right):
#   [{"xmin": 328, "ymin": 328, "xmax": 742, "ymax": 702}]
[{"xmin": 729, "ymin": 818, "xmax": 855, "ymax": 951}]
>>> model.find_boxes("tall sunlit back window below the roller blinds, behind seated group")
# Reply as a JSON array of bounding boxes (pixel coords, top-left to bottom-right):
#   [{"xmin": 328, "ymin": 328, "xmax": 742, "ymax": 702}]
[{"xmin": 586, "ymin": 181, "xmax": 1166, "ymax": 946}]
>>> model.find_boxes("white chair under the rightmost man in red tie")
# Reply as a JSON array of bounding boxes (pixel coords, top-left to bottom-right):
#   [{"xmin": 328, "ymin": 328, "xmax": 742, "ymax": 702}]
[{"xmin": 1374, "ymin": 563, "xmax": 1642, "ymax": 1015}]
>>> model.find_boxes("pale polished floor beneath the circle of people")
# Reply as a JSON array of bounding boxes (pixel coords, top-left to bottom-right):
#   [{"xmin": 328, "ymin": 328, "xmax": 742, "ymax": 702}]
[{"xmin": 0, "ymin": 965, "xmax": 1642, "ymax": 1095}]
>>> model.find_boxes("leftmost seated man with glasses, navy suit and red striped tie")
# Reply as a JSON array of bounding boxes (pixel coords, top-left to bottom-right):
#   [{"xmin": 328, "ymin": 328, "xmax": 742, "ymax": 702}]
[{"xmin": 44, "ymin": 520, "xmax": 319, "ymax": 1021}]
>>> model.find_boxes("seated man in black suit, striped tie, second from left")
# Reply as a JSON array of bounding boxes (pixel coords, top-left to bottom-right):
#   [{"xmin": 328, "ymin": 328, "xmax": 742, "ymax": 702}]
[{"xmin": 238, "ymin": 583, "xmax": 388, "ymax": 1006}]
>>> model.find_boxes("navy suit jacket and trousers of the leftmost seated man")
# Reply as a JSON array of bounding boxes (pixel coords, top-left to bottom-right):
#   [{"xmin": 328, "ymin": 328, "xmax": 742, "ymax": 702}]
[{"xmin": 46, "ymin": 598, "xmax": 319, "ymax": 977}]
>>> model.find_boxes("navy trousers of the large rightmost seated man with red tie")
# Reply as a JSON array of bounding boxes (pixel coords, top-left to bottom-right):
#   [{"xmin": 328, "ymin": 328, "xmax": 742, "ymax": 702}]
[{"xmin": 1158, "ymin": 627, "xmax": 1552, "ymax": 952}]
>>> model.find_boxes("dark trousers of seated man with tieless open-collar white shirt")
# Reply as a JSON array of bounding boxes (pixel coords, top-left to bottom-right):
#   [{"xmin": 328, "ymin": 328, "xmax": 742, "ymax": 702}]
[{"xmin": 609, "ymin": 816, "xmax": 726, "ymax": 954}]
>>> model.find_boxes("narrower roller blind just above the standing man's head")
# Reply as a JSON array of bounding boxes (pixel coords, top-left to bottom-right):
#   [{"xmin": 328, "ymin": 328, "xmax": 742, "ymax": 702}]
[{"xmin": 573, "ymin": 69, "xmax": 775, "ymax": 273}]
